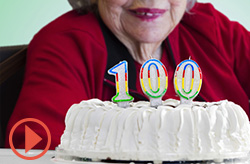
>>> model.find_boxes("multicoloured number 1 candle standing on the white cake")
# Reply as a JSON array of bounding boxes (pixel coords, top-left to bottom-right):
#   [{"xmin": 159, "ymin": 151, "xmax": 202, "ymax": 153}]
[{"xmin": 108, "ymin": 61, "xmax": 134, "ymax": 108}]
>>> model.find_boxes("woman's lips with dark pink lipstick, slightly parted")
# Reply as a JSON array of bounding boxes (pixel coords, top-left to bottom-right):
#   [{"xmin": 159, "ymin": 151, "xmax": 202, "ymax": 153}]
[{"xmin": 129, "ymin": 8, "xmax": 166, "ymax": 21}]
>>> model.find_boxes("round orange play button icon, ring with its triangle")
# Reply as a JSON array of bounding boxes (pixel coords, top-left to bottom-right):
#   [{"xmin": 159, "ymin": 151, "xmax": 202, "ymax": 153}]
[{"xmin": 9, "ymin": 118, "xmax": 51, "ymax": 160}]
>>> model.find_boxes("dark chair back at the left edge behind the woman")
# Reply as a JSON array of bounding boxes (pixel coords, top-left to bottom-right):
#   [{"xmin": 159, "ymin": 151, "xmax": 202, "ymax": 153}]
[{"xmin": 0, "ymin": 45, "xmax": 27, "ymax": 147}]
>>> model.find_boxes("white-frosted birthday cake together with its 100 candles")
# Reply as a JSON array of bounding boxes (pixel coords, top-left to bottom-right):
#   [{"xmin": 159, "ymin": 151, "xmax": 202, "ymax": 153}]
[{"xmin": 56, "ymin": 59, "xmax": 250, "ymax": 161}]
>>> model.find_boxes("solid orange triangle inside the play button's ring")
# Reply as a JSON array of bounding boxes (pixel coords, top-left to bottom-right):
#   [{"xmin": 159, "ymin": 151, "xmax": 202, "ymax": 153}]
[{"xmin": 25, "ymin": 125, "xmax": 42, "ymax": 153}]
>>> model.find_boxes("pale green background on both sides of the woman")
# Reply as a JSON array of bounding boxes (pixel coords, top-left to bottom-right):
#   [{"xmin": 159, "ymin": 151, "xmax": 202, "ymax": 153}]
[{"xmin": 0, "ymin": 0, "xmax": 250, "ymax": 46}]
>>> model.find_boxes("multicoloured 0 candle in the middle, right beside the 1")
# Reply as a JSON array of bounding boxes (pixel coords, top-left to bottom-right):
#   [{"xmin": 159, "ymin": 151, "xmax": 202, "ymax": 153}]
[{"xmin": 140, "ymin": 59, "xmax": 168, "ymax": 107}]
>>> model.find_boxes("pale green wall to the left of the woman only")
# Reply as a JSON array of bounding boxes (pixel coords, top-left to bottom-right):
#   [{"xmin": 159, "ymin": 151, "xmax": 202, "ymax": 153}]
[{"xmin": 0, "ymin": 0, "xmax": 71, "ymax": 46}]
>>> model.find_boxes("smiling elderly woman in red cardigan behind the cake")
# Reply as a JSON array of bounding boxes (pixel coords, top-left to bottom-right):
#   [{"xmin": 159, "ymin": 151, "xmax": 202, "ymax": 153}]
[{"xmin": 6, "ymin": 0, "xmax": 250, "ymax": 149}]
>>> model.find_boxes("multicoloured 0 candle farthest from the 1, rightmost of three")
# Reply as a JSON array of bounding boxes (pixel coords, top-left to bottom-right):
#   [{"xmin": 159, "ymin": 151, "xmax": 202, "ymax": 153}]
[{"xmin": 174, "ymin": 59, "xmax": 202, "ymax": 104}]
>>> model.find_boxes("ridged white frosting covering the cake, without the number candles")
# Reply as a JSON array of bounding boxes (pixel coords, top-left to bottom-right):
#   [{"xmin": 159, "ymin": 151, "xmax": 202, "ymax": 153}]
[{"xmin": 59, "ymin": 99, "xmax": 250, "ymax": 161}]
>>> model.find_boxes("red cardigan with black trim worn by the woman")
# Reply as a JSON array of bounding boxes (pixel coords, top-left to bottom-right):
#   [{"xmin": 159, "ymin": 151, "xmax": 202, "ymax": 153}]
[{"xmin": 6, "ymin": 3, "xmax": 250, "ymax": 149}]
